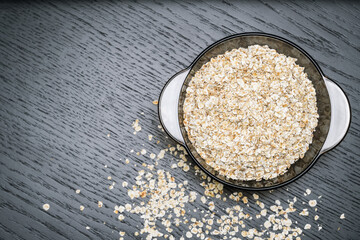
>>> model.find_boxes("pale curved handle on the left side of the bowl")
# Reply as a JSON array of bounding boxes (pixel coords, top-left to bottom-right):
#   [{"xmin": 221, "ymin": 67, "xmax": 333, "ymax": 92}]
[{"xmin": 158, "ymin": 68, "xmax": 190, "ymax": 145}]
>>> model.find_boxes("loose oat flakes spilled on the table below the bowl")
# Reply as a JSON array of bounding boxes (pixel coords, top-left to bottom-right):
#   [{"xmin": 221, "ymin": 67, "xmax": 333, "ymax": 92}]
[{"xmin": 114, "ymin": 120, "xmax": 322, "ymax": 240}]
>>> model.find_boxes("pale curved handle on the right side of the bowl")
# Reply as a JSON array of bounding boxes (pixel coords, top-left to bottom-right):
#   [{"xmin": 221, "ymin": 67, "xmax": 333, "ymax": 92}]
[{"xmin": 320, "ymin": 76, "xmax": 351, "ymax": 154}]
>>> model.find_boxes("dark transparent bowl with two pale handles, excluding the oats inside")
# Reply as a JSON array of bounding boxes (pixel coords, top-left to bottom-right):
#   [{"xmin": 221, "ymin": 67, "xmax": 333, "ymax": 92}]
[{"xmin": 158, "ymin": 33, "xmax": 351, "ymax": 190}]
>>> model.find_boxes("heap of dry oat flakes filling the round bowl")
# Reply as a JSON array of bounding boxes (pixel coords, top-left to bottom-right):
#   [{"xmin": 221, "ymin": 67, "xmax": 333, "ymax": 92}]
[{"xmin": 183, "ymin": 45, "xmax": 319, "ymax": 180}]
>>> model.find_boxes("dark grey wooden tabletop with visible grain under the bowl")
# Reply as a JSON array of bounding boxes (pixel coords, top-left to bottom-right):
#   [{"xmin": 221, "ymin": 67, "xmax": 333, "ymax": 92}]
[{"xmin": 0, "ymin": 1, "xmax": 360, "ymax": 239}]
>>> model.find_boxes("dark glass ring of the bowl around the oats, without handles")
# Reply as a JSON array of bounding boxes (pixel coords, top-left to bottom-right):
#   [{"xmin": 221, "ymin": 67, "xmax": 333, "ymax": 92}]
[{"xmin": 178, "ymin": 33, "xmax": 331, "ymax": 190}]
